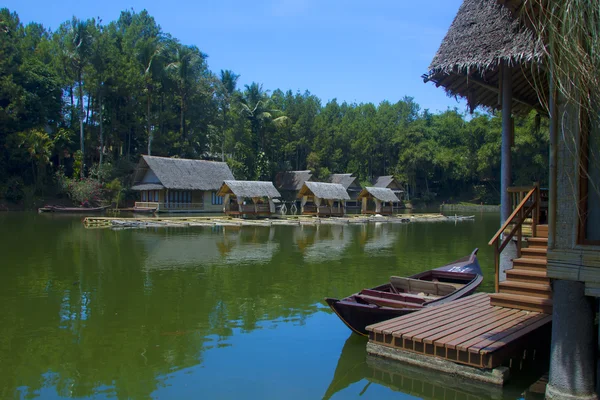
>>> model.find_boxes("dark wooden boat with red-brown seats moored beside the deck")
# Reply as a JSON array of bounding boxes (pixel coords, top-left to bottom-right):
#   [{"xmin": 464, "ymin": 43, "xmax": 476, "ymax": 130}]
[{"xmin": 325, "ymin": 249, "xmax": 483, "ymax": 336}]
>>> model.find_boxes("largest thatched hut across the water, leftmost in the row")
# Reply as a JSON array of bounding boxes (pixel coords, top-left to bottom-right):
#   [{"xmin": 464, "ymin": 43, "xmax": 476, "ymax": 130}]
[{"xmin": 131, "ymin": 156, "xmax": 234, "ymax": 212}]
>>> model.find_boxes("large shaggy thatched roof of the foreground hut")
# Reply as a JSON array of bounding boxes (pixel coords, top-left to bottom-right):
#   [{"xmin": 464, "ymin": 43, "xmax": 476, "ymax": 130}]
[{"xmin": 423, "ymin": 0, "xmax": 547, "ymax": 113}]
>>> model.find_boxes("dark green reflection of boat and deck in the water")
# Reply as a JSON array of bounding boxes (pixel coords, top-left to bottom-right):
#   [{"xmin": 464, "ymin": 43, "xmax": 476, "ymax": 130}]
[{"xmin": 323, "ymin": 335, "xmax": 547, "ymax": 400}]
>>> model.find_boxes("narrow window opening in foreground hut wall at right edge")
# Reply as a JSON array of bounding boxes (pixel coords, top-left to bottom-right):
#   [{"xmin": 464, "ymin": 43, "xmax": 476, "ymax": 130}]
[{"xmin": 579, "ymin": 113, "xmax": 600, "ymax": 245}]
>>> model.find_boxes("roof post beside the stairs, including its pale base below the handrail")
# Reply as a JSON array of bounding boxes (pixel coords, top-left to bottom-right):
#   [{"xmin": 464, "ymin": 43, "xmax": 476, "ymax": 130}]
[{"xmin": 500, "ymin": 62, "xmax": 517, "ymax": 281}]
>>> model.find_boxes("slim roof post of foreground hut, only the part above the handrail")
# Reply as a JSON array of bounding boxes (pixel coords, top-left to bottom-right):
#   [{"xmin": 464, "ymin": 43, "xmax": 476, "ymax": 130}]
[{"xmin": 500, "ymin": 62, "xmax": 512, "ymax": 225}]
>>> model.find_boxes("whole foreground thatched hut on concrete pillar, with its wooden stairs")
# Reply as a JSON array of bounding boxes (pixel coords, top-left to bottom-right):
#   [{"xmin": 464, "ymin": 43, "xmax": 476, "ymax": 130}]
[{"xmin": 424, "ymin": 0, "xmax": 600, "ymax": 399}]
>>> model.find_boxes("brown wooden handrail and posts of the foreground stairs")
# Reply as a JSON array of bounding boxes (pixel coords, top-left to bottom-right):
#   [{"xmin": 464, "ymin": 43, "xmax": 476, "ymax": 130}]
[{"xmin": 488, "ymin": 184, "xmax": 540, "ymax": 293}]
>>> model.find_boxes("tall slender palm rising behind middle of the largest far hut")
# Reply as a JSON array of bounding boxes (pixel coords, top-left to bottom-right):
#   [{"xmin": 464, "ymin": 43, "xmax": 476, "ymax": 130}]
[{"xmin": 166, "ymin": 43, "xmax": 206, "ymax": 148}]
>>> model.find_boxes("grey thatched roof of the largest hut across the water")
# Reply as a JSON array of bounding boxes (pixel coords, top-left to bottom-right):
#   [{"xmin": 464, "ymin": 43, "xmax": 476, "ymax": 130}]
[{"xmin": 133, "ymin": 156, "xmax": 234, "ymax": 190}]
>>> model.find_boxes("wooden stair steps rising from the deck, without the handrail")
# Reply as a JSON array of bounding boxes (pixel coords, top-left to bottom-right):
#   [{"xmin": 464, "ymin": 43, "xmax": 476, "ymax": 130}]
[{"xmin": 490, "ymin": 225, "xmax": 552, "ymax": 314}]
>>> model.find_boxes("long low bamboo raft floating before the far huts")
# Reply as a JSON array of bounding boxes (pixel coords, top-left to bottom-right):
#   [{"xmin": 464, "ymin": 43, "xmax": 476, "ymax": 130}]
[{"xmin": 83, "ymin": 214, "xmax": 470, "ymax": 230}]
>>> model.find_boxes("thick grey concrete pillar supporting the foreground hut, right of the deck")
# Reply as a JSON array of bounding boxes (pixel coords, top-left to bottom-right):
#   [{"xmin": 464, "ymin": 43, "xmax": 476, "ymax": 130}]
[{"xmin": 546, "ymin": 280, "xmax": 598, "ymax": 400}]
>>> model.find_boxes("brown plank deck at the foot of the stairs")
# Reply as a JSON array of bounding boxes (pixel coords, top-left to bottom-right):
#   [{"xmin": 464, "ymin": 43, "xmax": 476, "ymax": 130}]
[{"xmin": 367, "ymin": 293, "xmax": 552, "ymax": 369}]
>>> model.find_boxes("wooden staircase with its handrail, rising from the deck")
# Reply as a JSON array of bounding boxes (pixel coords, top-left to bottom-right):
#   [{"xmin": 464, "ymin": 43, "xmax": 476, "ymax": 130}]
[{"xmin": 490, "ymin": 186, "xmax": 552, "ymax": 314}]
